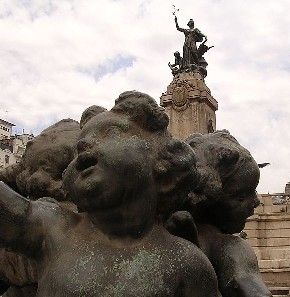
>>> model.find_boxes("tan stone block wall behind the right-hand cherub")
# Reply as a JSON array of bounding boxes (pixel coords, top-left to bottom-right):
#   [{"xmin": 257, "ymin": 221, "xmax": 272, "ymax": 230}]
[{"xmin": 245, "ymin": 195, "xmax": 290, "ymax": 290}]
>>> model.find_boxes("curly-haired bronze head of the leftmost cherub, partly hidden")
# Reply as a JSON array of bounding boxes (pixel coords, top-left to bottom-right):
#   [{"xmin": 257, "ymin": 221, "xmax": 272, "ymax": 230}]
[{"xmin": 14, "ymin": 119, "xmax": 80, "ymax": 200}]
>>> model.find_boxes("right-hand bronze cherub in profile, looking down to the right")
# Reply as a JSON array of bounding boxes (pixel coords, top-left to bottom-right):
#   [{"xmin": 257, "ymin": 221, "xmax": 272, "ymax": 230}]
[{"xmin": 167, "ymin": 130, "xmax": 271, "ymax": 297}]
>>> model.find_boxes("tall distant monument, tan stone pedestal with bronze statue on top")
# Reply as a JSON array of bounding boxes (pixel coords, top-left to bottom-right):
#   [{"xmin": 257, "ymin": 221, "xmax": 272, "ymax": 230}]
[{"xmin": 160, "ymin": 13, "xmax": 218, "ymax": 139}]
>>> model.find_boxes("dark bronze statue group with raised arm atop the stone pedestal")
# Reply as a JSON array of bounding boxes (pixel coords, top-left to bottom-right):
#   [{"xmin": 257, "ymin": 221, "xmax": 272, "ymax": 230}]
[{"xmin": 168, "ymin": 13, "xmax": 213, "ymax": 77}]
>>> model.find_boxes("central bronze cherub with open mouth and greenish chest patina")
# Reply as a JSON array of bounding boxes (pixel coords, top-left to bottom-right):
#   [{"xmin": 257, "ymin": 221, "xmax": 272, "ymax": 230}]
[{"xmin": 0, "ymin": 92, "xmax": 219, "ymax": 297}]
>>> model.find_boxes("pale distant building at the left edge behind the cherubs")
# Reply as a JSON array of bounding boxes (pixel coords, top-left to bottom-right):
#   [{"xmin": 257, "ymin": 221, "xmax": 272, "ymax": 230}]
[{"xmin": 0, "ymin": 119, "xmax": 34, "ymax": 168}]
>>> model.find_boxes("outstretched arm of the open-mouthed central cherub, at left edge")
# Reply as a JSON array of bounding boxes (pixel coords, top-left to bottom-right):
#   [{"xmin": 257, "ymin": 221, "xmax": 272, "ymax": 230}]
[{"xmin": 0, "ymin": 181, "xmax": 41, "ymax": 256}]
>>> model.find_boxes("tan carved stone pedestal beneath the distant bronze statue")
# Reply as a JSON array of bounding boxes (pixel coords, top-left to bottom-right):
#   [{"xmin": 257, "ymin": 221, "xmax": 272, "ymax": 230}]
[{"xmin": 160, "ymin": 72, "xmax": 218, "ymax": 139}]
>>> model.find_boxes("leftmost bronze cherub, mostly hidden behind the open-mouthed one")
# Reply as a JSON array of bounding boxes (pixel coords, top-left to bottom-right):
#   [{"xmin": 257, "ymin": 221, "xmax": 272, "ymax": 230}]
[{"xmin": 0, "ymin": 118, "xmax": 81, "ymax": 297}]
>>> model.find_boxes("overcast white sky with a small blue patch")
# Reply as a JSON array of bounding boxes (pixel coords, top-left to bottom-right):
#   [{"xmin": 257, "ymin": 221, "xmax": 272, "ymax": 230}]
[{"xmin": 0, "ymin": 0, "xmax": 290, "ymax": 193}]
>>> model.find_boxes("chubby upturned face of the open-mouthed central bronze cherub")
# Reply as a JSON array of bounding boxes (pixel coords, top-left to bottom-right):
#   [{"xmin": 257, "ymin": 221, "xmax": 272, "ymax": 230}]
[{"xmin": 64, "ymin": 111, "xmax": 156, "ymax": 212}]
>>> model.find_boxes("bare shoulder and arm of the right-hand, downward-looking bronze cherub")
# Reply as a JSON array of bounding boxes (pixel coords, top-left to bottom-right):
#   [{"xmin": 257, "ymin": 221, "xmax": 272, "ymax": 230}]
[{"xmin": 199, "ymin": 234, "xmax": 272, "ymax": 297}]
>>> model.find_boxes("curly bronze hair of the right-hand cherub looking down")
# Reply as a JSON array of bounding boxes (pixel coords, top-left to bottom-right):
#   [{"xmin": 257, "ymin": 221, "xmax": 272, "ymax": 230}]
[{"xmin": 185, "ymin": 130, "xmax": 258, "ymax": 208}]
